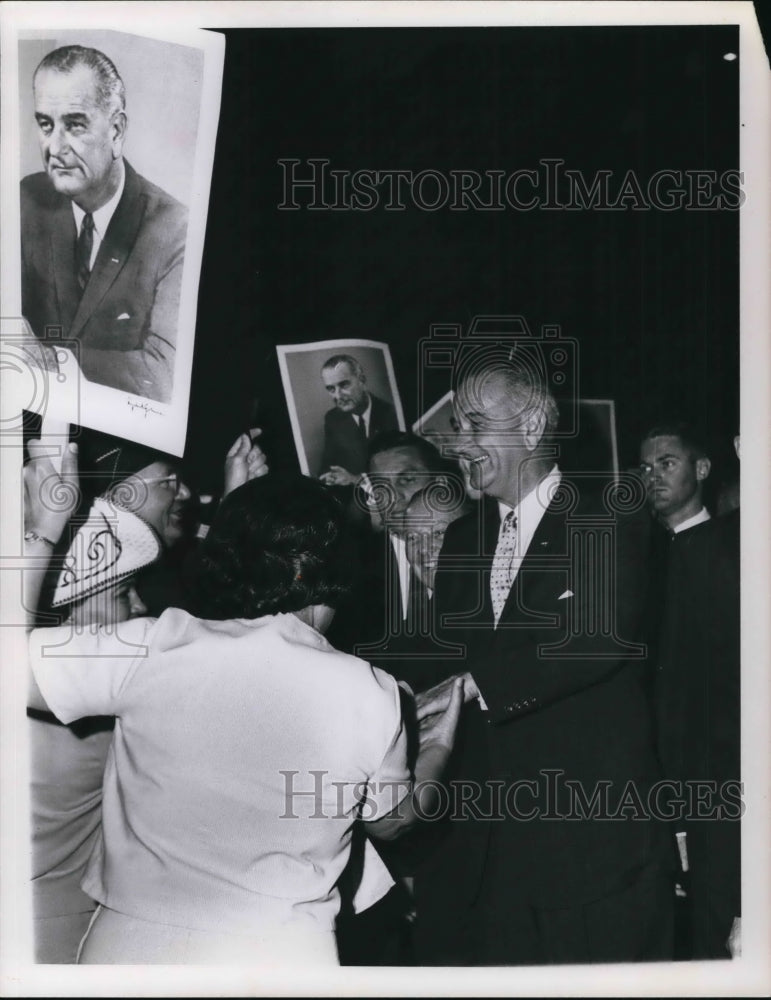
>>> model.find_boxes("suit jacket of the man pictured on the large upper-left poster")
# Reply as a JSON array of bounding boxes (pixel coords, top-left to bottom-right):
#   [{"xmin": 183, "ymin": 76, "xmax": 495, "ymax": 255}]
[{"xmin": 21, "ymin": 161, "xmax": 187, "ymax": 402}]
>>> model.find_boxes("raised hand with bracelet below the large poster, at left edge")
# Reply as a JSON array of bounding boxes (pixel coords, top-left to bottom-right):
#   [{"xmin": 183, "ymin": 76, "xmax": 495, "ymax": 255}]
[{"xmin": 24, "ymin": 438, "xmax": 80, "ymax": 542}]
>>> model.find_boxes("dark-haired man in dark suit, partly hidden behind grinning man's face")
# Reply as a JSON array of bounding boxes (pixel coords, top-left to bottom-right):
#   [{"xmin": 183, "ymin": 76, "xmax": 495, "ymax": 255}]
[{"xmin": 327, "ymin": 430, "xmax": 466, "ymax": 965}]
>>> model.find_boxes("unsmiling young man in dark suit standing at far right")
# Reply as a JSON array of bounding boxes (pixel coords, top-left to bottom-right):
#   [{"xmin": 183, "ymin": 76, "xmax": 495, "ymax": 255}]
[{"xmin": 641, "ymin": 424, "xmax": 742, "ymax": 959}]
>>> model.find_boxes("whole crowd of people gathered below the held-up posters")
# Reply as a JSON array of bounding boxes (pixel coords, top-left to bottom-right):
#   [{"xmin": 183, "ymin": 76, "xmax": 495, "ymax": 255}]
[{"xmin": 25, "ymin": 342, "xmax": 743, "ymax": 966}]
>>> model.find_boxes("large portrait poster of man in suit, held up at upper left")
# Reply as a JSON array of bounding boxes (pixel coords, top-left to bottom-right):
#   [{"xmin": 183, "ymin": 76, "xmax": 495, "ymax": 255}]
[{"xmin": 9, "ymin": 29, "xmax": 224, "ymax": 458}]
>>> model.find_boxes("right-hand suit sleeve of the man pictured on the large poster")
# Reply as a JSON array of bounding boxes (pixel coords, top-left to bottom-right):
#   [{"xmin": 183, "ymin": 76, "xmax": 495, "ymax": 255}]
[{"xmin": 75, "ymin": 205, "xmax": 187, "ymax": 403}]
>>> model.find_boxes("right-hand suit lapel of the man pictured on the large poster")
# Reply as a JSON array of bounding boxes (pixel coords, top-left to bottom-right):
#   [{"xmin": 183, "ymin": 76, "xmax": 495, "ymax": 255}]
[{"xmin": 70, "ymin": 161, "xmax": 144, "ymax": 337}]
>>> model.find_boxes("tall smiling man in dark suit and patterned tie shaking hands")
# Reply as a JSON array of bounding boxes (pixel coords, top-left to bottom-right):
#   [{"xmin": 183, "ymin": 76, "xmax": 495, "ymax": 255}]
[{"xmin": 416, "ymin": 352, "xmax": 672, "ymax": 965}]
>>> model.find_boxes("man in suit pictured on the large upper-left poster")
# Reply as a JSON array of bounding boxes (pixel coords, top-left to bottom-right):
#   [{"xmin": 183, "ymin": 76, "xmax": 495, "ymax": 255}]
[{"xmin": 21, "ymin": 45, "xmax": 187, "ymax": 403}]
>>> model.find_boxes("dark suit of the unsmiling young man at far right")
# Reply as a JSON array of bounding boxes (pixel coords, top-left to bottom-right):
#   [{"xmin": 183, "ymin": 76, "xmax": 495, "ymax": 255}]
[{"xmin": 655, "ymin": 512, "xmax": 741, "ymax": 958}]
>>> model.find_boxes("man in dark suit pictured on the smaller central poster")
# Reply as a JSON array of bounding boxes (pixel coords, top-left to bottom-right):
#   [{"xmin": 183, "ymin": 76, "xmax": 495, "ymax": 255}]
[{"xmin": 319, "ymin": 354, "xmax": 399, "ymax": 486}]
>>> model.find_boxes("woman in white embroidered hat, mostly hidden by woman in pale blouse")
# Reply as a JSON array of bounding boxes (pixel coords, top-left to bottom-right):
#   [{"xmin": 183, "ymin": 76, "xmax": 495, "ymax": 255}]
[{"xmin": 25, "ymin": 440, "xmax": 161, "ymax": 964}]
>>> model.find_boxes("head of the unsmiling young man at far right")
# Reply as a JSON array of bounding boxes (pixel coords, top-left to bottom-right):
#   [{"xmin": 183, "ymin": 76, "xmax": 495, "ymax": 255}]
[{"xmin": 640, "ymin": 423, "xmax": 711, "ymax": 533}]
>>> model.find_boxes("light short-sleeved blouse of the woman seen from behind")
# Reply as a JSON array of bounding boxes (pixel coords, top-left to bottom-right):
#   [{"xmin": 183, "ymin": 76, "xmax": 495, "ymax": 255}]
[{"xmin": 30, "ymin": 608, "xmax": 409, "ymax": 934}]
